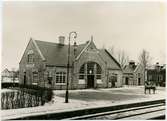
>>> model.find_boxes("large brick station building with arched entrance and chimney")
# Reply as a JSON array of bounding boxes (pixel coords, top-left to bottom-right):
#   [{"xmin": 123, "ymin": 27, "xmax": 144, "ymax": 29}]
[{"xmin": 19, "ymin": 36, "xmax": 123, "ymax": 89}]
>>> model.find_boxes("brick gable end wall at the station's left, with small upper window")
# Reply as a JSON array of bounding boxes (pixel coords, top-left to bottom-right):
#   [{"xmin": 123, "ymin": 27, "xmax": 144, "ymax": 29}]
[{"xmin": 19, "ymin": 40, "xmax": 45, "ymax": 86}]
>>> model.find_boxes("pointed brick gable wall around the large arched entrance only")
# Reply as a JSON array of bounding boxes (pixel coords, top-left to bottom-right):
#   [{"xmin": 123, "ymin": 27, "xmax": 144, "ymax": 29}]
[{"xmin": 73, "ymin": 43, "xmax": 107, "ymax": 88}]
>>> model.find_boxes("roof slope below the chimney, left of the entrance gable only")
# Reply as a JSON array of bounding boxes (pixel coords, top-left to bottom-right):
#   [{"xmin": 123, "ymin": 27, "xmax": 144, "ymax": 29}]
[{"xmin": 35, "ymin": 40, "xmax": 87, "ymax": 66}]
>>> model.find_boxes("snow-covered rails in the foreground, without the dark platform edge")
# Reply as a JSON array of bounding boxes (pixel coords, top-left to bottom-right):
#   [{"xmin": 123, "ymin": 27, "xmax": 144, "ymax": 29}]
[{"xmin": 63, "ymin": 101, "xmax": 165, "ymax": 120}]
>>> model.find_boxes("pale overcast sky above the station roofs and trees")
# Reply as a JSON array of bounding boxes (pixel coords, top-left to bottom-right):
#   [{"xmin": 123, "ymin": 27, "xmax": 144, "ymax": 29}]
[{"xmin": 2, "ymin": 2, "xmax": 166, "ymax": 69}]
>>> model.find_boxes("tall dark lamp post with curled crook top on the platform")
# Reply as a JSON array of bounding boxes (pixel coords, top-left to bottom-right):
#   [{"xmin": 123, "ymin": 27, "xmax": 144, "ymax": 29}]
[{"xmin": 65, "ymin": 31, "xmax": 77, "ymax": 103}]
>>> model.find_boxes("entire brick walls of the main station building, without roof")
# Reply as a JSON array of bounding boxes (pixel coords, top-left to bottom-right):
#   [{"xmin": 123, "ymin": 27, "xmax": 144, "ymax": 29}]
[{"xmin": 19, "ymin": 40, "xmax": 122, "ymax": 89}]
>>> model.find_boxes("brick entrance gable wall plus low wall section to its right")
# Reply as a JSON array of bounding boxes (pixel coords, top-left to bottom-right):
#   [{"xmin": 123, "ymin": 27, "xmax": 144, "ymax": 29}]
[{"xmin": 73, "ymin": 43, "xmax": 122, "ymax": 88}]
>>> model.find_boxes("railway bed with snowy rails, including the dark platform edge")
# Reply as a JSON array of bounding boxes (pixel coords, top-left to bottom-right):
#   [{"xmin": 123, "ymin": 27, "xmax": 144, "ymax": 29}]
[{"xmin": 13, "ymin": 99, "xmax": 165, "ymax": 120}]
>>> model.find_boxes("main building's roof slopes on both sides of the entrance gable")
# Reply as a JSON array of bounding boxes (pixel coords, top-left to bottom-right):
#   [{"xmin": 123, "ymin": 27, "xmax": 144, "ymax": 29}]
[{"xmin": 35, "ymin": 40, "xmax": 121, "ymax": 70}]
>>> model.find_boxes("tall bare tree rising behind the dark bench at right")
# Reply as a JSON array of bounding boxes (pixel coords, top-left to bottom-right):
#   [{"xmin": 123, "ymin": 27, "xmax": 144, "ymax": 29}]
[{"xmin": 139, "ymin": 49, "xmax": 151, "ymax": 82}]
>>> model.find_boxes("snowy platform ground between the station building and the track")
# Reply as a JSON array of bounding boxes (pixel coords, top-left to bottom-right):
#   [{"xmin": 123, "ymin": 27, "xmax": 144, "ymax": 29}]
[{"xmin": 1, "ymin": 86, "xmax": 165, "ymax": 119}]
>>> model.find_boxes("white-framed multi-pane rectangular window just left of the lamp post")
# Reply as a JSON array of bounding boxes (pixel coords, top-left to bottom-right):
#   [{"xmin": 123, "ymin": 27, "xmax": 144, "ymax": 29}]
[{"xmin": 56, "ymin": 72, "xmax": 66, "ymax": 83}]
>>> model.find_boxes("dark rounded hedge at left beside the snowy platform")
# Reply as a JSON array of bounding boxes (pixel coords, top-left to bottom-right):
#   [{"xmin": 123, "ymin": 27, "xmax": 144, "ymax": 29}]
[{"xmin": 1, "ymin": 83, "xmax": 53, "ymax": 109}]
